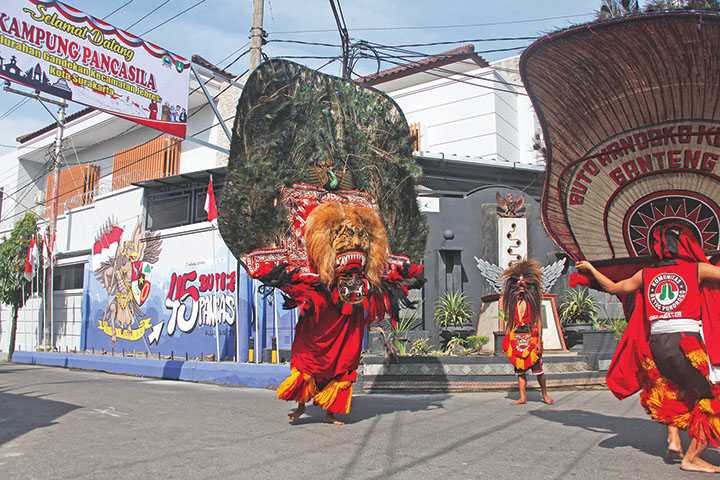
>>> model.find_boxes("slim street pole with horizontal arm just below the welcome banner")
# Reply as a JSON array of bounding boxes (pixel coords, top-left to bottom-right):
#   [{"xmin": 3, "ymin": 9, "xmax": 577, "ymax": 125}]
[{"xmin": 3, "ymin": 82, "xmax": 67, "ymax": 350}]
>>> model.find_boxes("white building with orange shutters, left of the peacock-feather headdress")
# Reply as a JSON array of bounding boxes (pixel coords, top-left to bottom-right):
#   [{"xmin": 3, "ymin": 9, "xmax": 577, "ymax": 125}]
[{"xmin": 0, "ymin": 56, "xmax": 240, "ymax": 351}]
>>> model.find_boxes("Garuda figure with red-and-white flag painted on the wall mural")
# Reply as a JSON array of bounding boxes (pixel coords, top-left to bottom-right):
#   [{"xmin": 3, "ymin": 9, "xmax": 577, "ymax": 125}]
[{"xmin": 93, "ymin": 220, "xmax": 162, "ymax": 342}]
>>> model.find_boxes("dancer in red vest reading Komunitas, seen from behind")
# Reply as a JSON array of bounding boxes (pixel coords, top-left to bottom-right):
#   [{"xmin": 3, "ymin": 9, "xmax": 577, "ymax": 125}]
[{"xmin": 577, "ymin": 225, "xmax": 720, "ymax": 473}]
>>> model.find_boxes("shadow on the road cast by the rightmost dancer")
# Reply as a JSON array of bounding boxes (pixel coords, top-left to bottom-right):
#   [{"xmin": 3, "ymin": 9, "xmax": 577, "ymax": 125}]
[{"xmin": 528, "ymin": 409, "xmax": 720, "ymax": 464}]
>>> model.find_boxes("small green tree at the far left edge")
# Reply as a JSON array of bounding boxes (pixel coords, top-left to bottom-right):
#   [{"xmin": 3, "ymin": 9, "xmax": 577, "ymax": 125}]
[{"xmin": 0, "ymin": 213, "xmax": 37, "ymax": 360}]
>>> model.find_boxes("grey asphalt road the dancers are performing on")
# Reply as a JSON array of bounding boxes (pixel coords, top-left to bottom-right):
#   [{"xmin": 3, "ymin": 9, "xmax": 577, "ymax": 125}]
[{"xmin": 0, "ymin": 364, "xmax": 720, "ymax": 480}]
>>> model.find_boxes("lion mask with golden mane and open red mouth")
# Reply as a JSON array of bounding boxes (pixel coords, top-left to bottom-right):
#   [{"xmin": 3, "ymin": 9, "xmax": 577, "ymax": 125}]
[{"xmin": 305, "ymin": 202, "xmax": 388, "ymax": 303}]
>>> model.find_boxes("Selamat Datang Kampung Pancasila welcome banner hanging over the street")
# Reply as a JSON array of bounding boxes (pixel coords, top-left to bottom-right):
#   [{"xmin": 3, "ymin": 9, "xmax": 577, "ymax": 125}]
[{"xmin": 0, "ymin": 0, "xmax": 190, "ymax": 138}]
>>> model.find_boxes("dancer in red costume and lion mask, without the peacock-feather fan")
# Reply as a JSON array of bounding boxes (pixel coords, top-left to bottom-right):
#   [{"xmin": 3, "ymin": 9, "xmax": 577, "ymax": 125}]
[{"xmin": 257, "ymin": 202, "xmax": 422, "ymax": 425}]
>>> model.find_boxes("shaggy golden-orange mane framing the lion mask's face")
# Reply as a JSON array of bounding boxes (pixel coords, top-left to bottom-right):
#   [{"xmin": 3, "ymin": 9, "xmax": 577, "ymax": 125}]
[{"xmin": 305, "ymin": 202, "xmax": 389, "ymax": 289}]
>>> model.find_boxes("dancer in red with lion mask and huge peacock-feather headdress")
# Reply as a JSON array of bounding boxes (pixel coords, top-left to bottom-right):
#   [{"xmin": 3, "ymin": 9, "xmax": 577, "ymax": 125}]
[{"xmin": 219, "ymin": 60, "xmax": 427, "ymax": 423}]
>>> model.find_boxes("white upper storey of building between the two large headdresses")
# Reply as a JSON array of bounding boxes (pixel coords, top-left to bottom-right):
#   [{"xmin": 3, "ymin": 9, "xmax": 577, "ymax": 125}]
[{"xmin": 361, "ymin": 45, "xmax": 542, "ymax": 164}]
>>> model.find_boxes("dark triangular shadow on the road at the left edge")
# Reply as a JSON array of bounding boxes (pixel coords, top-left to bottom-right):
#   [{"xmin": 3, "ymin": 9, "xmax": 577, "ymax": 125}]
[{"xmin": 0, "ymin": 390, "xmax": 81, "ymax": 445}]
